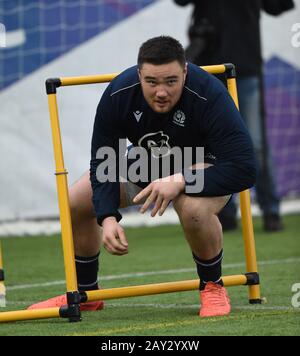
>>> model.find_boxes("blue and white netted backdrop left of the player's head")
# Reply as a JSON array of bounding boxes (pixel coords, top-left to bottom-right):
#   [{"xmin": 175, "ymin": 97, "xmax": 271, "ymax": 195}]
[{"xmin": 0, "ymin": 0, "xmax": 189, "ymax": 221}]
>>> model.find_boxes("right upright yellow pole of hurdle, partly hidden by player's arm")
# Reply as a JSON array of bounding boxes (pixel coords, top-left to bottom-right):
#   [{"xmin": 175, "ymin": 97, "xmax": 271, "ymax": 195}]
[{"xmin": 227, "ymin": 78, "xmax": 261, "ymax": 303}]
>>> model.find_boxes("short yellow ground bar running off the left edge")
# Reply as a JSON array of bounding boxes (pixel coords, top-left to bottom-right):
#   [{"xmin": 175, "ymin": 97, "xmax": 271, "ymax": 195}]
[{"xmin": 0, "ymin": 308, "xmax": 60, "ymax": 323}]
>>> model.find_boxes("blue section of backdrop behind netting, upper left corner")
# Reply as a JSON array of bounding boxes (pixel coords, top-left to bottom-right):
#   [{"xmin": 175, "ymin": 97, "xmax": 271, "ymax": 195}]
[{"xmin": 0, "ymin": 0, "xmax": 155, "ymax": 90}]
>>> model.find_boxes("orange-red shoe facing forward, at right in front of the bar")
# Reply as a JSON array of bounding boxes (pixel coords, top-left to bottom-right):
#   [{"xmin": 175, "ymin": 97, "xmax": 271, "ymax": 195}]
[{"xmin": 199, "ymin": 282, "xmax": 231, "ymax": 318}]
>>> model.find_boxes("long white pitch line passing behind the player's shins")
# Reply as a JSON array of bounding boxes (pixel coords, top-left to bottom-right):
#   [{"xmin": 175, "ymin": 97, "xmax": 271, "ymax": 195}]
[{"xmin": 6, "ymin": 257, "xmax": 300, "ymax": 291}]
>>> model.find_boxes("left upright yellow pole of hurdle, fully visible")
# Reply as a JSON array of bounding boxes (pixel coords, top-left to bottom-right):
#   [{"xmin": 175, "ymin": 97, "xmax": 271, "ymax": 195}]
[{"xmin": 48, "ymin": 94, "xmax": 77, "ymax": 292}]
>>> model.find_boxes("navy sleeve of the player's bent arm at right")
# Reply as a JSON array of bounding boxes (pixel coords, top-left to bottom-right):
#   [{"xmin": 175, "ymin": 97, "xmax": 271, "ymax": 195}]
[{"xmin": 185, "ymin": 88, "xmax": 256, "ymax": 197}]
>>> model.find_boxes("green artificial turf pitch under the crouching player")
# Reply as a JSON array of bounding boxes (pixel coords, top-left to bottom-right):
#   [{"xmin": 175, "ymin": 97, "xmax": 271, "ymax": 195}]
[{"xmin": 0, "ymin": 215, "xmax": 300, "ymax": 336}]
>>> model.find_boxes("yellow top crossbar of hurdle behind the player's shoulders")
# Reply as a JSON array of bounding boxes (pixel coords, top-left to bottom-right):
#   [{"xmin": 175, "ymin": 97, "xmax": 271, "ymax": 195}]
[{"xmin": 60, "ymin": 64, "xmax": 226, "ymax": 86}]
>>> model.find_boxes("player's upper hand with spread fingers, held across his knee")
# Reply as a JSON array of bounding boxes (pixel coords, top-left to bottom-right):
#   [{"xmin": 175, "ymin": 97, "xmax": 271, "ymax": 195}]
[{"xmin": 133, "ymin": 173, "xmax": 185, "ymax": 217}]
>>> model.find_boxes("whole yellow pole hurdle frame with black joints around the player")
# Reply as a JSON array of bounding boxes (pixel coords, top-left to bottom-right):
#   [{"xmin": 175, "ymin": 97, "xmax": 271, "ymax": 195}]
[{"xmin": 0, "ymin": 64, "xmax": 261, "ymax": 322}]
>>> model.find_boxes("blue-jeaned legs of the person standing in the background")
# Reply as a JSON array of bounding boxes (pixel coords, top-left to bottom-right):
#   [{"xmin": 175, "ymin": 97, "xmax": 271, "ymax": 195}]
[{"xmin": 219, "ymin": 77, "xmax": 282, "ymax": 231}]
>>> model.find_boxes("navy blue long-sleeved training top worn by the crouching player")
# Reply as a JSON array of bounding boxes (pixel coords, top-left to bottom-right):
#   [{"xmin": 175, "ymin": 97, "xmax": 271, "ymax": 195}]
[{"xmin": 90, "ymin": 63, "xmax": 256, "ymax": 224}]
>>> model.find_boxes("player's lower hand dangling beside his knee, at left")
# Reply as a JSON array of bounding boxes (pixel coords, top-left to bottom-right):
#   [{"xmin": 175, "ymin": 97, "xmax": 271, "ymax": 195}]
[{"xmin": 102, "ymin": 216, "xmax": 128, "ymax": 256}]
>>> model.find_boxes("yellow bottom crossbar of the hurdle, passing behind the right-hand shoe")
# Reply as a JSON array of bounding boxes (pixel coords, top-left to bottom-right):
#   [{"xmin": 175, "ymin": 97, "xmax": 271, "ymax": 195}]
[{"xmin": 86, "ymin": 275, "xmax": 247, "ymax": 301}]
